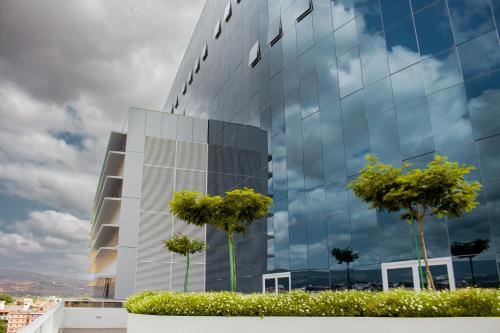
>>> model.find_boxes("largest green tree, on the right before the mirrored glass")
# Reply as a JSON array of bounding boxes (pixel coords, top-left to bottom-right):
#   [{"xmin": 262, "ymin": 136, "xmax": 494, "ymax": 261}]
[{"xmin": 348, "ymin": 155, "xmax": 481, "ymax": 289}]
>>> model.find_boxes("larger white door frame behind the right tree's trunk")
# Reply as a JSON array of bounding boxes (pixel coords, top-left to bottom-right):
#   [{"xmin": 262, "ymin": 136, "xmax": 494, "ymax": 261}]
[{"xmin": 381, "ymin": 257, "xmax": 456, "ymax": 291}]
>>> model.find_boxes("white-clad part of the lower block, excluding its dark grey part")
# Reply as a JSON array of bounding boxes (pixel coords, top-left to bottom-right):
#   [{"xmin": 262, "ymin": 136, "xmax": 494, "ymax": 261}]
[{"xmin": 89, "ymin": 108, "xmax": 208, "ymax": 299}]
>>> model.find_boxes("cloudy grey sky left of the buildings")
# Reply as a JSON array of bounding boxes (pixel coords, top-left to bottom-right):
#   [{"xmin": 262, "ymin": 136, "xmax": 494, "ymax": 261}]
[{"xmin": 0, "ymin": 0, "xmax": 204, "ymax": 279}]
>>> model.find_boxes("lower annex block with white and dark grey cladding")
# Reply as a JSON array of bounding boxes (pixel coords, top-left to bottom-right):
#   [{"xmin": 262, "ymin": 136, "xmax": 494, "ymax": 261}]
[{"xmin": 89, "ymin": 108, "xmax": 268, "ymax": 299}]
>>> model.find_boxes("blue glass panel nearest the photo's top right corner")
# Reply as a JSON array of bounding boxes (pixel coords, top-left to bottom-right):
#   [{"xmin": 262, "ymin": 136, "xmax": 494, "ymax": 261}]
[{"xmin": 448, "ymin": 0, "xmax": 494, "ymax": 44}]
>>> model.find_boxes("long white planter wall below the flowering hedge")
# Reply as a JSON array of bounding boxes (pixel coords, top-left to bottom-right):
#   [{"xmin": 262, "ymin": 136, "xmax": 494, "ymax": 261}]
[{"xmin": 127, "ymin": 313, "xmax": 500, "ymax": 333}]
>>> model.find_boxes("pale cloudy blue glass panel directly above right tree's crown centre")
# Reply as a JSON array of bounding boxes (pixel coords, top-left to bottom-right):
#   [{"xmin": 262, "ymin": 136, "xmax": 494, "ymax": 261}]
[{"xmin": 396, "ymin": 97, "xmax": 434, "ymax": 159}]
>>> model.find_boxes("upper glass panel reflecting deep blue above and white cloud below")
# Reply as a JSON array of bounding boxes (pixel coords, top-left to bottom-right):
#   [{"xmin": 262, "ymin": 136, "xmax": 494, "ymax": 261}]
[{"xmin": 385, "ymin": 16, "xmax": 420, "ymax": 73}]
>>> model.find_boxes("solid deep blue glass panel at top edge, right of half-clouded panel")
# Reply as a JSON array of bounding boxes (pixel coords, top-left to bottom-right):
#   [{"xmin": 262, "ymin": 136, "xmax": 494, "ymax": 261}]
[{"xmin": 415, "ymin": 1, "xmax": 454, "ymax": 56}]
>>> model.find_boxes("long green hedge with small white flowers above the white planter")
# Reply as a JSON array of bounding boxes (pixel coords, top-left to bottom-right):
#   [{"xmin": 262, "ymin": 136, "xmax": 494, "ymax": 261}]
[{"xmin": 125, "ymin": 288, "xmax": 500, "ymax": 317}]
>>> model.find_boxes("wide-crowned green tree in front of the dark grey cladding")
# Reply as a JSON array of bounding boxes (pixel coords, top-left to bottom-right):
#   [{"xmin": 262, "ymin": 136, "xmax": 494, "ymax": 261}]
[{"xmin": 170, "ymin": 188, "xmax": 272, "ymax": 291}]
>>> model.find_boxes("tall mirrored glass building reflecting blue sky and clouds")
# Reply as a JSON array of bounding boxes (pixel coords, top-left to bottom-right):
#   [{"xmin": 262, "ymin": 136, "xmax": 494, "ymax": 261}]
[{"xmin": 164, "ymin": 0, "xmax": 500, "ymax": 291}]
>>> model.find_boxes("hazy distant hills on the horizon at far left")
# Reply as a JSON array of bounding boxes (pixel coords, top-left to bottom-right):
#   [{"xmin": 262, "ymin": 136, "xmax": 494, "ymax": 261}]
[{"xmin": 0, "ymin": 268, "xmax": 90, "ymax": 297}]
